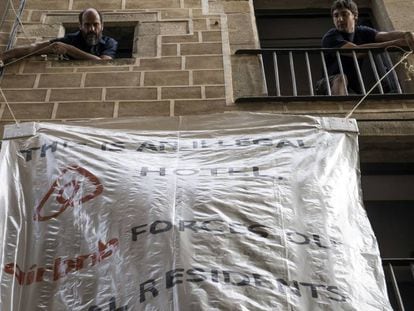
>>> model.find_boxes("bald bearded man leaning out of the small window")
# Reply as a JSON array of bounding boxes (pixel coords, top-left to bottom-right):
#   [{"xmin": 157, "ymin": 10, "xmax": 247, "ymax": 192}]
[{"xmin": 0, "ymin": 8, "xmax": 118, "ymax": 67}]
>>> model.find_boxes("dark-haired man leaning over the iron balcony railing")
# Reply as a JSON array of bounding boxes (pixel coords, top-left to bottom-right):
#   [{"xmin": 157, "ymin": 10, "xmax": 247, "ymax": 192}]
[{"xmin": 316, "ymin": 0, "xmax": 414, "ymax": 95}]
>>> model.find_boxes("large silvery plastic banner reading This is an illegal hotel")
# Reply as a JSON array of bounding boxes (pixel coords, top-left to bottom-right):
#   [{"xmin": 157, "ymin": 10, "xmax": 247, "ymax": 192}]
[{"xmin": 0, "ymin": 113, "xmax": 391, "ymax": 311}]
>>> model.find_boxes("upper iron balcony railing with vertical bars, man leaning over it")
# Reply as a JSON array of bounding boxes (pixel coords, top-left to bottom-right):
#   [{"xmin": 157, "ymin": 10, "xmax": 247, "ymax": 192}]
[{"xmin": 236, "ymin": 48, "xmax": 414, "ymax": 102}]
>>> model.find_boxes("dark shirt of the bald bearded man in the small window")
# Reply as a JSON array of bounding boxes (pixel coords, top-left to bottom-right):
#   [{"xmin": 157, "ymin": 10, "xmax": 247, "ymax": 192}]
[{"xmin": 50, "ymin": 31, "xmax": 118, "ymax": 58}]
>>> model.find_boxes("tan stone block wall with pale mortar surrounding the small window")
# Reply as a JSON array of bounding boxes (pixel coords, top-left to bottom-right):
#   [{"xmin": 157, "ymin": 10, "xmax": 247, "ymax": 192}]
[{"xmin": 0, "ymin": 0, "xmax": 246, "ymax": 132}]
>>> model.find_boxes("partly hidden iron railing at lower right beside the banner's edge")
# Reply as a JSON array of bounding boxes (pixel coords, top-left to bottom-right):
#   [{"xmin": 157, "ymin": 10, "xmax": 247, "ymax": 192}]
[{"xmin": 382, "ymin": 258, "xmax": 414, "ymax": 311}]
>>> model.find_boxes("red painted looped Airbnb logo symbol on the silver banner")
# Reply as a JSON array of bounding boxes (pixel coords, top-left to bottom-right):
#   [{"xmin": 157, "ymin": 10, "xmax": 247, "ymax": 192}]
[{"xmin": 33, "ymin": 165, "xmax": 103, "ymax": 221}]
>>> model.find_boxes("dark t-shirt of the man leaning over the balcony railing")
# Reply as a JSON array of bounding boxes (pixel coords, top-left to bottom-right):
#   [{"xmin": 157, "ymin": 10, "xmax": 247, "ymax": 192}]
[{"xmin": 322, "ymin": 26, "xmax": 377, "ymax": 93}]
